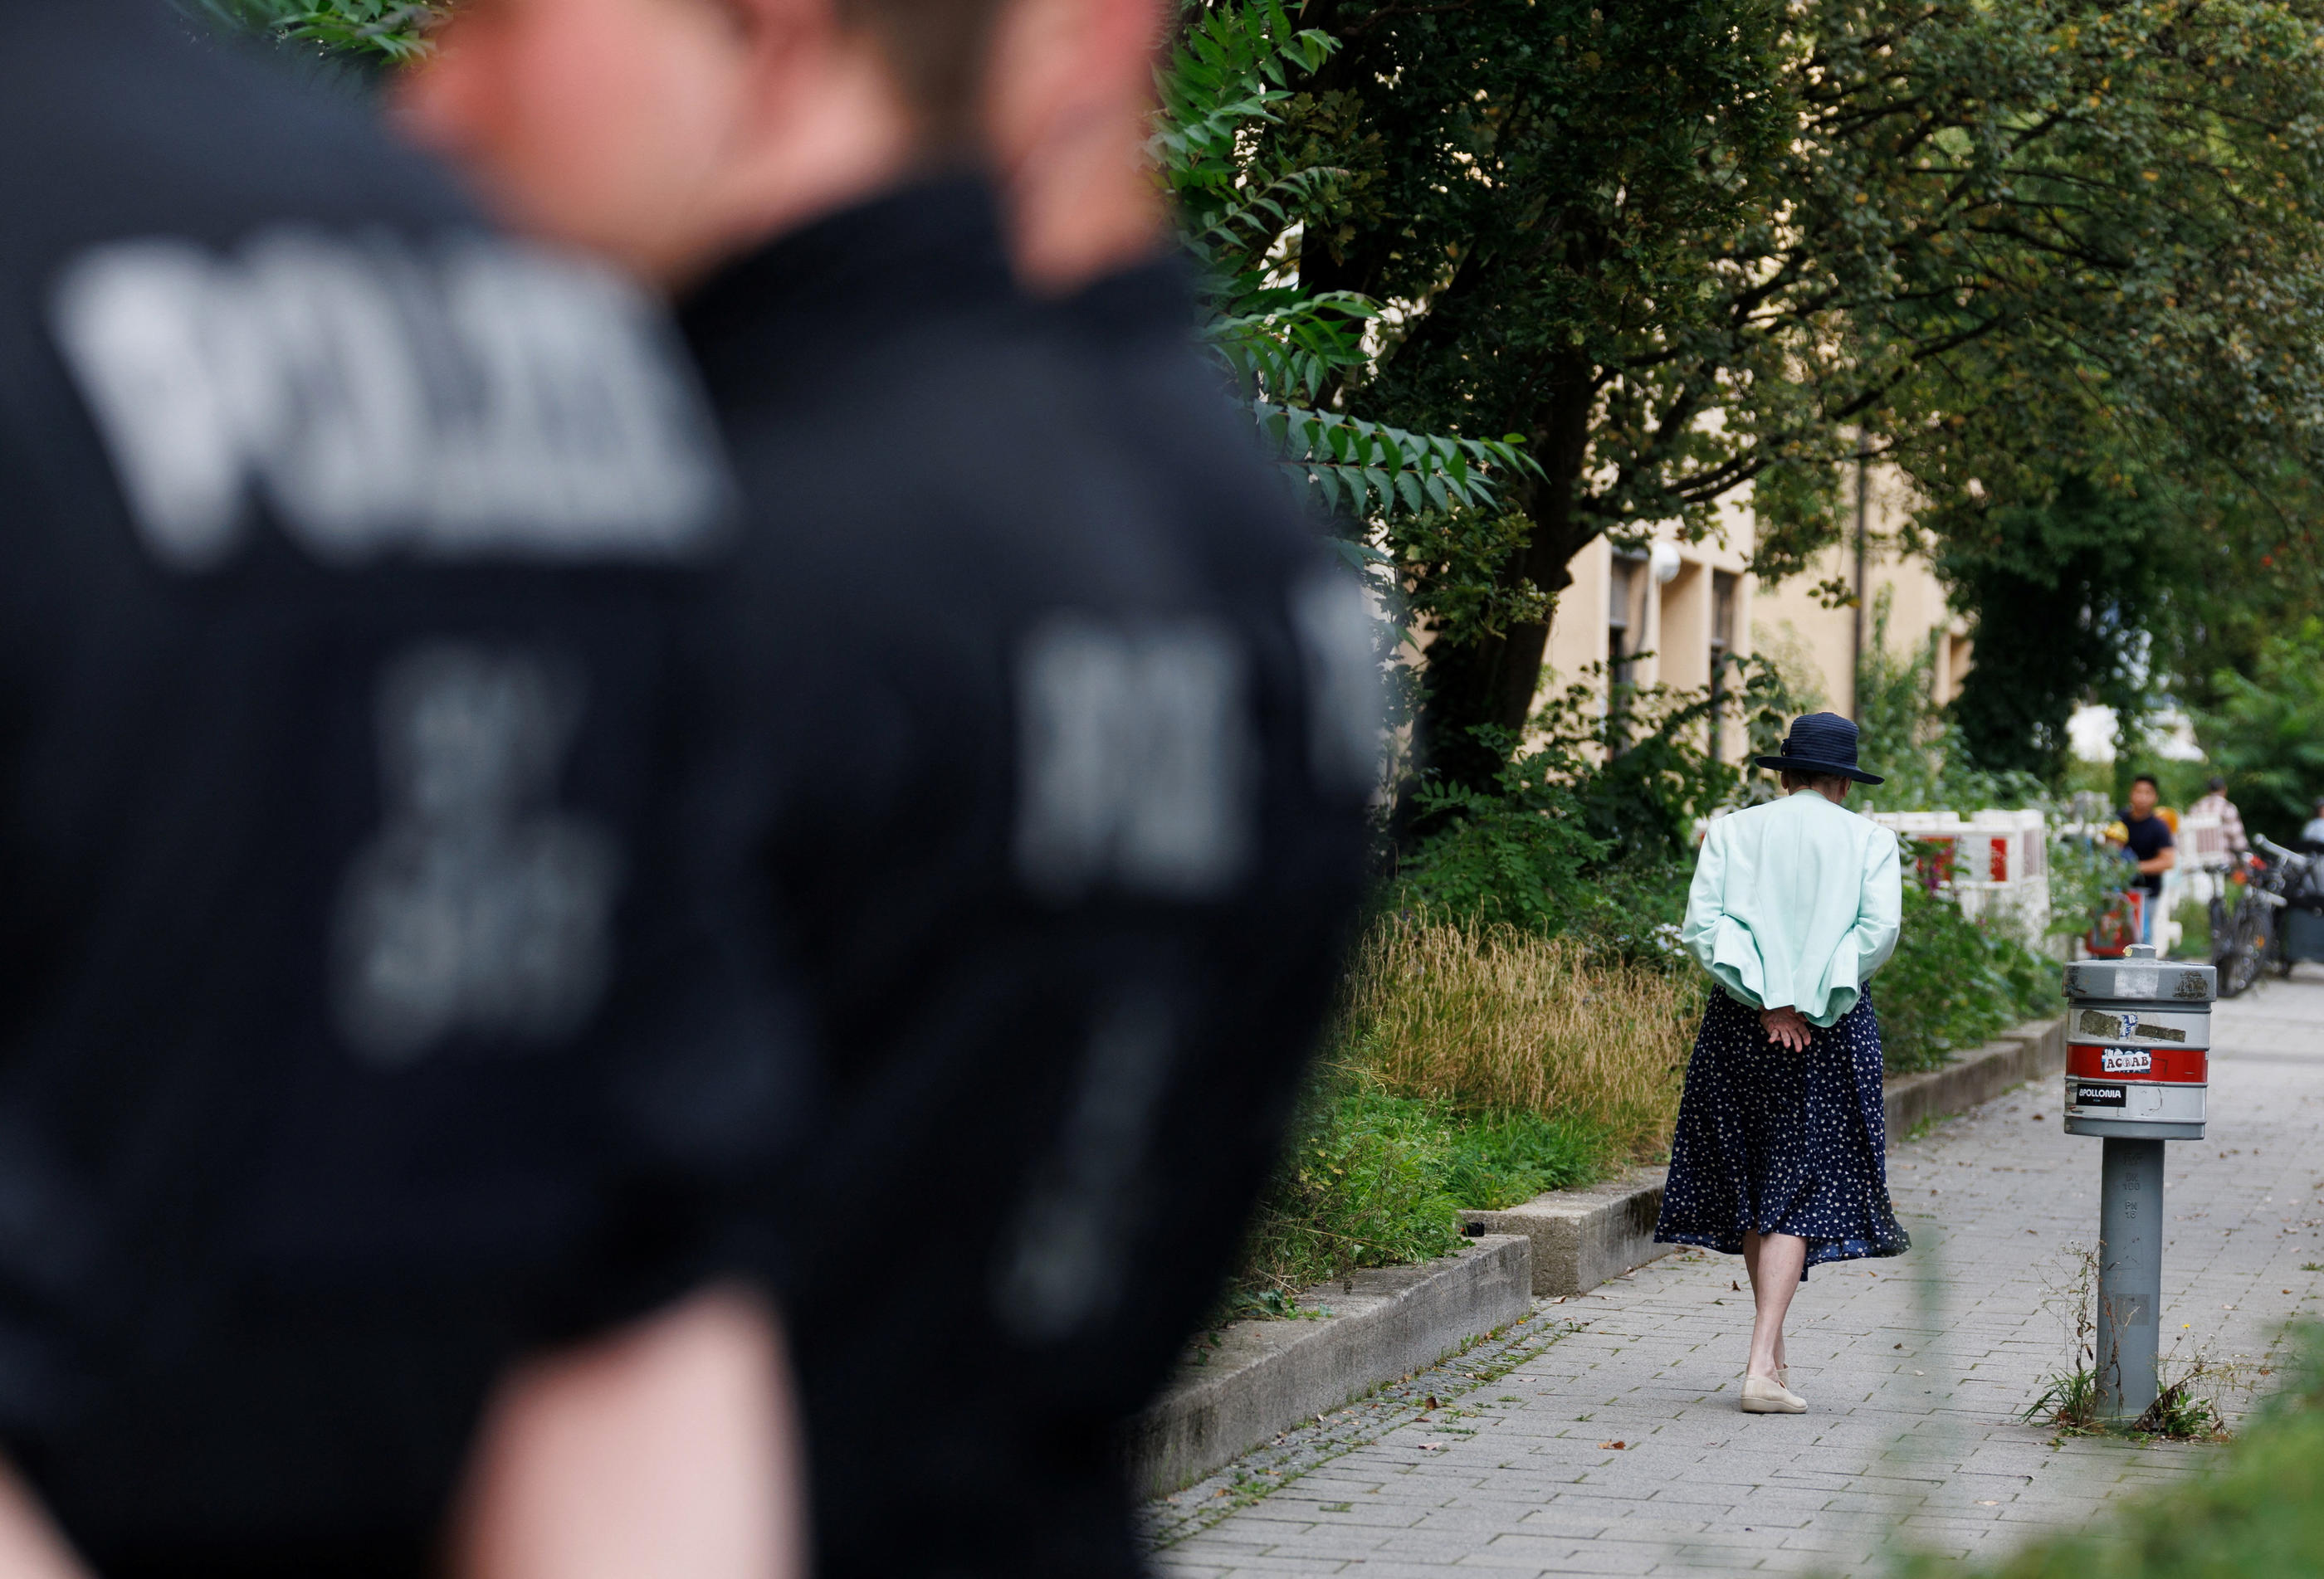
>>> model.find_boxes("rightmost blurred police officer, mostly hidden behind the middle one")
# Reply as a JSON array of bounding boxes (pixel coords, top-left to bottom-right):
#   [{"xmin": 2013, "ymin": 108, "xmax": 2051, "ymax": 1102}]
[{"xmin": 981, "ymin": 0, "xmax": 1383, "ymax": 1458}]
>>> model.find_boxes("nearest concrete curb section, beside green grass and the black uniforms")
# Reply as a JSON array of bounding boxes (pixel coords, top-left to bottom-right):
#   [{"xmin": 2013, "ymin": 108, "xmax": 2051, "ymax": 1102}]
[{"xmin": 1122, "ymin": 1235, "xmax": 1534, "ymax": 1498}]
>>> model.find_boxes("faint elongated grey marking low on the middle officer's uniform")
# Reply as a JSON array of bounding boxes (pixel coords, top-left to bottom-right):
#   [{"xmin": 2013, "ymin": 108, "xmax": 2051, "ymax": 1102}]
[{"xmin": 993, "ymin": 994, "xmax": 1176, "ymax": 1343}]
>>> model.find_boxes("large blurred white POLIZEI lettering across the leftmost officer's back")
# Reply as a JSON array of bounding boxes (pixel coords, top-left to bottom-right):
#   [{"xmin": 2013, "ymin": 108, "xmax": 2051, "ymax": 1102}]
[{"xmin": 53, "ymin": 230, "xmax": 725, "ymax": 571}]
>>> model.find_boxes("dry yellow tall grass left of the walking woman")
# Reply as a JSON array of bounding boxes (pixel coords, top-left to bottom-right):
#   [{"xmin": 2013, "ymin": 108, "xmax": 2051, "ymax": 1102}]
[{"xmin": 1343, "ymin": 917, "xmax": 1702, "ymax": 1158}]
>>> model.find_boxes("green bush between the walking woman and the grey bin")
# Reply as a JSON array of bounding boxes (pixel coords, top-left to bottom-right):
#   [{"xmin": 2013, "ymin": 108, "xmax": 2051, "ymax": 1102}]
[{"xmin": 1871, "ymin": 878, "xmax": 2062, "ymax": 1075}]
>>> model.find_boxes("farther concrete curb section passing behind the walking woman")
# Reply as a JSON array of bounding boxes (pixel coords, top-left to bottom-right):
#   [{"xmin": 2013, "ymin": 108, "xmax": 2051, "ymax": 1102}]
[{"xmin": 1462, "ymin": 1015, "xmax": 2066, "ymax": 1296}]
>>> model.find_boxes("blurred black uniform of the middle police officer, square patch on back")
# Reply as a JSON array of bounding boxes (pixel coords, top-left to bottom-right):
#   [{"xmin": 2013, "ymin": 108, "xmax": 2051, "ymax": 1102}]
[{"xmin": 681, "ymin": 183, "xmax": 1369, "ymax": 1579}]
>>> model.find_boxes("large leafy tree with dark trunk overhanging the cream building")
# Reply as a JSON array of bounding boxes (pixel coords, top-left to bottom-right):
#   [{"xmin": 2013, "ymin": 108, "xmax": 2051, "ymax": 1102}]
[{"xmin": 1276, "ymin": 0, "xmax": 2324, "ymax": 782}]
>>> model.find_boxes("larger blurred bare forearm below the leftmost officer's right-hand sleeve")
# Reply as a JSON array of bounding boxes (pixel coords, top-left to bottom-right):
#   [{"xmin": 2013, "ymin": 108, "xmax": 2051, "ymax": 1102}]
[{"xmin": 451, "ymin": 1291, "xmax": 807, "ymax": 1579}]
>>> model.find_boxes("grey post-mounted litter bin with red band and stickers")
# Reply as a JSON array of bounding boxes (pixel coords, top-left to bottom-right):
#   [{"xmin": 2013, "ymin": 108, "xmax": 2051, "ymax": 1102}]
[{"xmin": 2063, "ymin": 945, "xmax": 2217, "ymax": 1423}]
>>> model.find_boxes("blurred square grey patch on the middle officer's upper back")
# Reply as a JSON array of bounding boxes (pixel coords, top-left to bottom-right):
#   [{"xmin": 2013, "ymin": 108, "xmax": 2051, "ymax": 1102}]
[{"xmin": 1016, "ymin": 616, "xmax": 1257, "ymax": 901}]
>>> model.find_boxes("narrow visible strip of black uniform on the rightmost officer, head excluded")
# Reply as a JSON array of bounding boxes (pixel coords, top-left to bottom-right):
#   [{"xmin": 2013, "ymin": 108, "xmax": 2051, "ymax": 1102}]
[{"xmin": 1034, "ymin": 253, "xmax": 1383, "ymax": 1416}]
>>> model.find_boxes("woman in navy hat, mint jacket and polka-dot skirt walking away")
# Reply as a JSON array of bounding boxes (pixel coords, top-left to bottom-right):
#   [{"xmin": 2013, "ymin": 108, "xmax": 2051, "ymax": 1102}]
[{"xmin": 1655, "ymin": 713, "xmax": 1911, "ymax": 1414}]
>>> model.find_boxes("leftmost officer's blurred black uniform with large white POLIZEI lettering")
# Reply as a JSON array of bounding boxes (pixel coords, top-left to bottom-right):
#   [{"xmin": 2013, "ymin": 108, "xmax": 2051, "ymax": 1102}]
[{"xmin": 0, "ymin": 0, "xmax": 804, "ymax": 1577}]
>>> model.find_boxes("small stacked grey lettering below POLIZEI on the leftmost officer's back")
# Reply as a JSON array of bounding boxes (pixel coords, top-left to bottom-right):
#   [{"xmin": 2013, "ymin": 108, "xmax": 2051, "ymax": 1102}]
[{"xmin": 332, "ymin": 641, "xmax": 622, "ymax": 1066}]
